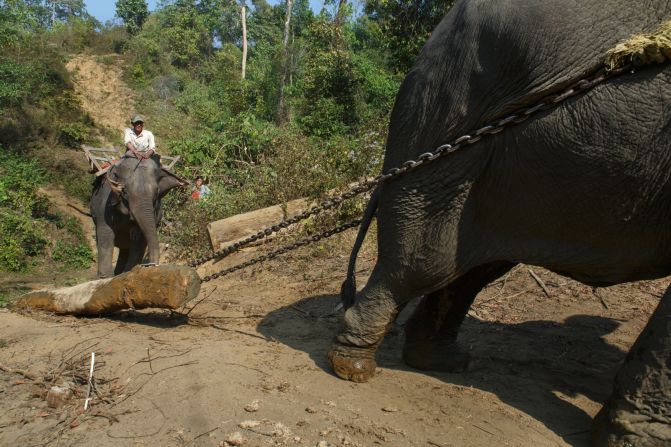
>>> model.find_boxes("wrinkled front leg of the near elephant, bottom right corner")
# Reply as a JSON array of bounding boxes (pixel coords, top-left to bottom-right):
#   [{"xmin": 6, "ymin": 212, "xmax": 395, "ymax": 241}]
[{"xmin": 592, "ymin": 287, "xmax": 671, "ymax": 447}]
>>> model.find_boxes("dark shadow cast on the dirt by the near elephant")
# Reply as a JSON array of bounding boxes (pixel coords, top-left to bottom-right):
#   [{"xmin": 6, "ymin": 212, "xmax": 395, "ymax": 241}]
[{"xmin": 258, "ymin": 295, "xmax": 626, "ymax": 446}]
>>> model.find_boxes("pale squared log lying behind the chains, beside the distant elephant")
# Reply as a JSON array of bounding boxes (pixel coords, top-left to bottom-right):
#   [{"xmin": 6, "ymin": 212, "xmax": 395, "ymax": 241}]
[{"xmin": 207, "ymin": 199, "xmax": 311, "ymax": 251}]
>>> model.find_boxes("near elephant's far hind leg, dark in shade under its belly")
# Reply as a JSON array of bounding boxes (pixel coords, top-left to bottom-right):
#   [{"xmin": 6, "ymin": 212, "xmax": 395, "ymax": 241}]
[{"xmin": 403, "ymin": 262, "xmax": 515, "ymax": 372}]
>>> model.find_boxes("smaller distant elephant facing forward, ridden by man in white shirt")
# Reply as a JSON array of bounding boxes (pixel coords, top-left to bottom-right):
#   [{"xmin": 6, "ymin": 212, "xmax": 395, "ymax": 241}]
[{"xmin": 90, "ymin": 157, "xmax": 185, "ymax": 278}]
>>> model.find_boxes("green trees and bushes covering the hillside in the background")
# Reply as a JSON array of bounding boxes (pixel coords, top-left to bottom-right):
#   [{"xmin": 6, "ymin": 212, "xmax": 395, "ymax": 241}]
[{"xmin": 0, "ymin": 0, "xmax": 452, "ymax": 271}]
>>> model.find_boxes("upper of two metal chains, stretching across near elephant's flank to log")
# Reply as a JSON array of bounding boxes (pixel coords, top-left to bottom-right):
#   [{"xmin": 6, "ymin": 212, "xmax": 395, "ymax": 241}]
[{"xmin": 188, "ymin": 64, "xmax": 634, "ymax": 270}]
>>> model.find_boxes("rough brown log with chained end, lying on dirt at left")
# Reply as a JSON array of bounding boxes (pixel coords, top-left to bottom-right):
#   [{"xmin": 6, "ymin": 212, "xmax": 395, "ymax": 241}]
[{"xmin": 9, "ymin": 264, "xmax": 201, "ymax": 315}]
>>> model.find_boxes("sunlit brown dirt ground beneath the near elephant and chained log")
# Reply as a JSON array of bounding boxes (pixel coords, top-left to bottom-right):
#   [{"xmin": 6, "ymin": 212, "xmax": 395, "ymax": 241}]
[{"xmin": 0, "ymin": 237, "xmax": 668, "ymax": 447}]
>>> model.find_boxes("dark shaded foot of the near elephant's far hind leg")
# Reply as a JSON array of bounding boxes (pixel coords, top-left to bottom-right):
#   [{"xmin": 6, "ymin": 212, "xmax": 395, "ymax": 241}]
[{"xmin": 403, "ymin": 339, "xmax": 471, "ymax": 373}]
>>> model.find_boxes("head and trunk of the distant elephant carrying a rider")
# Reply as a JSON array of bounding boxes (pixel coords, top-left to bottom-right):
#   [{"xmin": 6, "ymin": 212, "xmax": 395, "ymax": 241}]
[{"xmin": 109, "ymin": 158, "xmax": 188, "ymax": 264}]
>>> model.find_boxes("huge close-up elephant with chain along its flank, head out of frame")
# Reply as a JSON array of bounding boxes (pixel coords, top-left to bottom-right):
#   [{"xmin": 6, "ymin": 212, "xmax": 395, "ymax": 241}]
[{"xmin": 329, "ymin": 0, "xmax": 671, "ymax": 445}]
